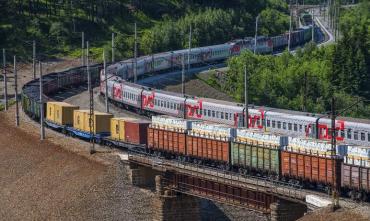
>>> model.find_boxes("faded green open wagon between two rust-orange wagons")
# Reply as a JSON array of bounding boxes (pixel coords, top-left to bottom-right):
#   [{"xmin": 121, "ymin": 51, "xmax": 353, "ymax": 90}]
[{"xmin": 231, "ymin": 142, "xmax": 280, "ymax": 175}]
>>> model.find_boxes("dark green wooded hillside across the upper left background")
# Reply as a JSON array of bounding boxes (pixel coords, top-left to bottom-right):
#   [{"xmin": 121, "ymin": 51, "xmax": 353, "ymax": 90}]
[{"xmin": 0, "ymin": 0, "xmax": 289, "ymax": 59}]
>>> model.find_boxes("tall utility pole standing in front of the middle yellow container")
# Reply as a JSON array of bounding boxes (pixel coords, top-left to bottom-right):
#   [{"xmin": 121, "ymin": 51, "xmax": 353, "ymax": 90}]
[{"xmin": 86, "ymin": 42, "xmax": 95, "ymax": 154}]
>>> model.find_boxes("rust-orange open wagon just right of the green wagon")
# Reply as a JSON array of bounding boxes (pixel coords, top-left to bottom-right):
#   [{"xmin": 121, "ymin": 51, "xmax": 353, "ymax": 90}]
[{"xmin": 281, "ymin": 149, "xmax": 343, "ymax": 187}]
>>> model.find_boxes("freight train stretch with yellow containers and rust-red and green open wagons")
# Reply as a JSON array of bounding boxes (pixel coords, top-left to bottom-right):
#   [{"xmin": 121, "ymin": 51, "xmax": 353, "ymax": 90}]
[{"xmin": 21, "ymin": 90, "xmax": 370, "ymax": 201}]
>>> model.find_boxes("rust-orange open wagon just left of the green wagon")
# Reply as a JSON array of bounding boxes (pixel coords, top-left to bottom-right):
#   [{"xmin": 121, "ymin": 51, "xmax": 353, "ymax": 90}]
[{"xmin": 186, "ymin": 135, "xmax": 230, "ymax": 163}]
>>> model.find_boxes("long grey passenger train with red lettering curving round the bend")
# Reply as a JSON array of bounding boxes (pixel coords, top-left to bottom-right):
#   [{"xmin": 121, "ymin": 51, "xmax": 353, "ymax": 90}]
[{"xmin": 100, "ymin": 26, "xmax": 370, "ymax": 148}]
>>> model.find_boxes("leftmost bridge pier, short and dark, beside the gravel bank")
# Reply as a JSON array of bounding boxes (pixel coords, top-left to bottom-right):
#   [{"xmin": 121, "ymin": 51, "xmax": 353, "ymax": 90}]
[{"xmin": 126, "ymin": 163, "xmax": 159, "ymax": 187}]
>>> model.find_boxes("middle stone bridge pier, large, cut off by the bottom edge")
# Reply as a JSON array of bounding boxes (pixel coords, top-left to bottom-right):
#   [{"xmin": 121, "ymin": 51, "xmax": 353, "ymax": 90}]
[{"xmin": 153, "ymin": 175, "xmax": 200, "ymax": 221}]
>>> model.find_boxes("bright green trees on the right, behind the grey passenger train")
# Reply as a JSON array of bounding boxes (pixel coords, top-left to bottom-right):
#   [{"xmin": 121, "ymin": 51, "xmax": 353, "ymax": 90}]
[{"xmin": 209, "ymin": 1, "xmax": 370, "ymax": 118}]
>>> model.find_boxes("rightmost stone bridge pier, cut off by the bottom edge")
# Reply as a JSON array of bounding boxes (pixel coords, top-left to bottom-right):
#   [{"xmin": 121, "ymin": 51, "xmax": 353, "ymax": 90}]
[{"xmin": 270, "ymin": 200, "xmax": 307, "ymax": 221}]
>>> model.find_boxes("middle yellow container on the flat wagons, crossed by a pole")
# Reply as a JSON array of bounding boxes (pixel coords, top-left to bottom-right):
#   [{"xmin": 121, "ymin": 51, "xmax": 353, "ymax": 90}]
[{"xmin": 73, "ymin": 110, "xmax": 113, "ymax": 134}]
